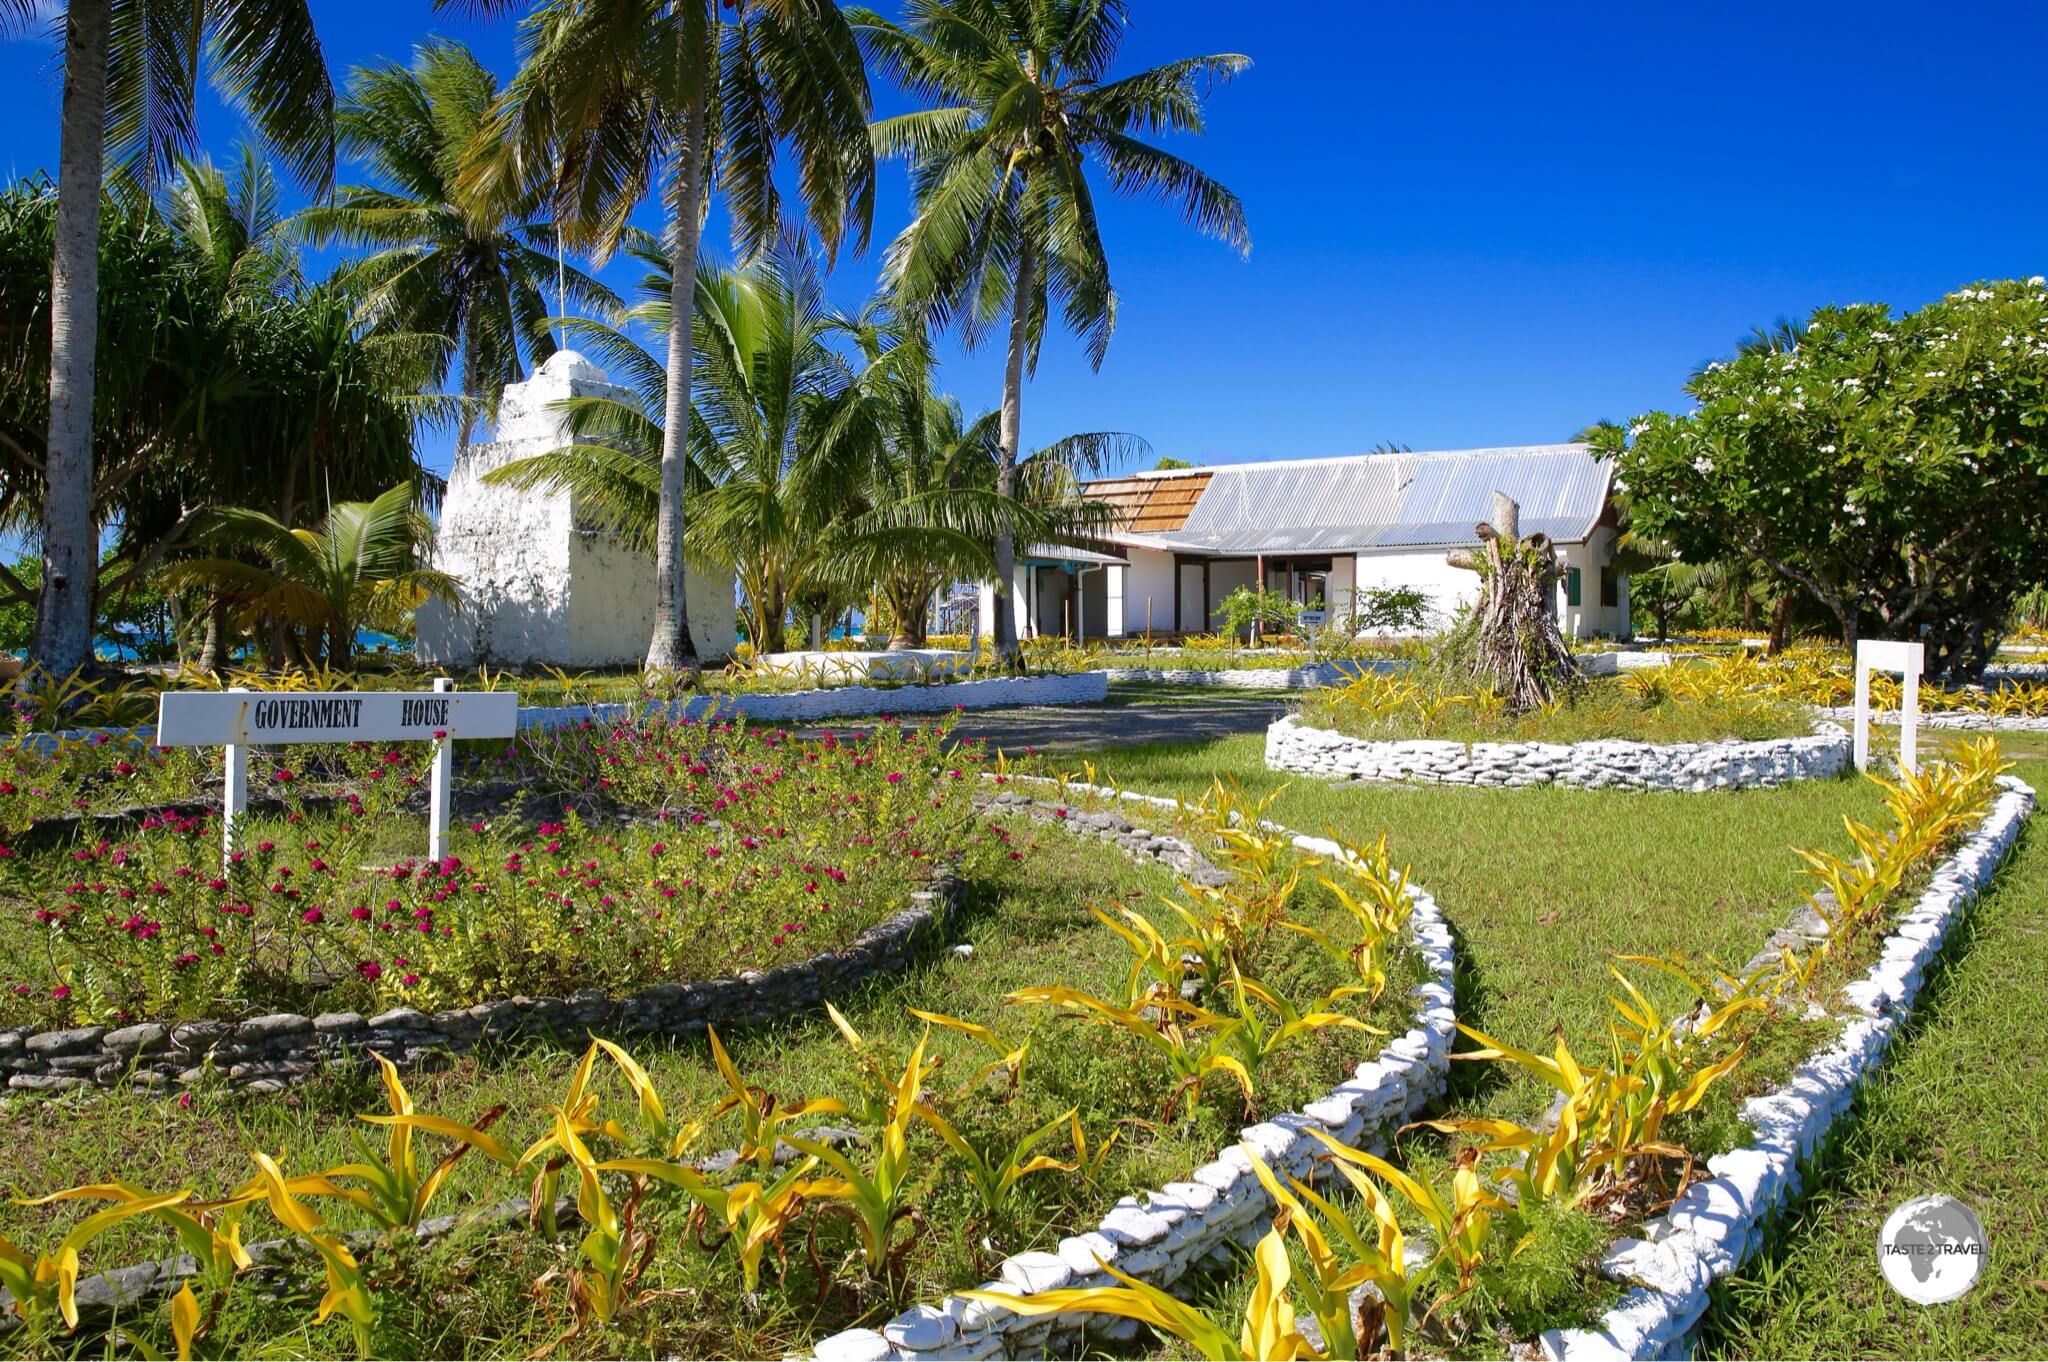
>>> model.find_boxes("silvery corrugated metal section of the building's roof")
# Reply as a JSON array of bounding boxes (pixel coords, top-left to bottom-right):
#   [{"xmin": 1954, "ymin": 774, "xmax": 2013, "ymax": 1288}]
[{"xmin": 1161, "ymin": 444, "xmax": 1612, "ymax": 553}]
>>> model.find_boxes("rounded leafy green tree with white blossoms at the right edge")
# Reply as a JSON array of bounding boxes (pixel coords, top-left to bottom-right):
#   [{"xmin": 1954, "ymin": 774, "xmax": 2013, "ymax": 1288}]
[{"xmin": 1604, "ymin": 279, "xmax": 2048, "ymax": 676}]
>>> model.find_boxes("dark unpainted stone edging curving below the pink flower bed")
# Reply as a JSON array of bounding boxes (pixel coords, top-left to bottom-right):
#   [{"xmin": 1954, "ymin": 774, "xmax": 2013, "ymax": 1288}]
[{"xmin": 0, "ymin": 866, "xmax": 961, "ymax": 1092}]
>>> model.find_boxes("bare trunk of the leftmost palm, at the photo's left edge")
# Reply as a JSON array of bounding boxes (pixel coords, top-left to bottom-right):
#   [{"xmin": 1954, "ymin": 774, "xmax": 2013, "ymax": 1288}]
[{"xmin": 35, "ymin": 0, "xmax": 113, "ymax": 676}]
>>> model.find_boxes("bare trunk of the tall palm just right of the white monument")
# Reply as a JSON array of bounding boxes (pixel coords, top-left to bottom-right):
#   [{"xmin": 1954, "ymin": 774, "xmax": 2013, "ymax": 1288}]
[{"xmin": 647, "ymin": 96, "xmax": 712, "ymax": 682}]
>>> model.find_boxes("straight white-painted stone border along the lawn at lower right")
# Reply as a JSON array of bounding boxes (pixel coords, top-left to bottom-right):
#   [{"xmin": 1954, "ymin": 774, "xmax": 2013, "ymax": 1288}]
[{"xmin": 1540, "ymin": 776, "xmax": 2034, "ymax": 1362}]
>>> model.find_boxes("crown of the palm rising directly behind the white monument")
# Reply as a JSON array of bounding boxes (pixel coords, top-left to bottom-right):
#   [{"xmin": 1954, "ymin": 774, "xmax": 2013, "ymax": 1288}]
[{"xmin": 297, "ymin": 39, "xmax": 618, "ymax": 444}]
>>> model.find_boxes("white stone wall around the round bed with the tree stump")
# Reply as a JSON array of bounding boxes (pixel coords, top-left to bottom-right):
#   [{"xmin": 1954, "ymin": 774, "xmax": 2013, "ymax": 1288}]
[{"xmin": 1266, "ymin": 715, "xmax": 1851, "ymax": 791}]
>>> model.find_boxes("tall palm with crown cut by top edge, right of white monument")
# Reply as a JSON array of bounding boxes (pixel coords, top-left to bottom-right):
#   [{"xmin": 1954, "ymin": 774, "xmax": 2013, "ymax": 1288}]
[{"xmin": 452, "ymin": 0, "xmax": 874, "ymax": 676}]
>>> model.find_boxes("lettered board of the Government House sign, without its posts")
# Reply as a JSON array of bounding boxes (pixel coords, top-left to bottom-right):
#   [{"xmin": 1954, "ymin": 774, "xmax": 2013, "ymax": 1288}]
[{"xmin": 156, "ymin": 690, "xmax": 518, "ymax": 748}]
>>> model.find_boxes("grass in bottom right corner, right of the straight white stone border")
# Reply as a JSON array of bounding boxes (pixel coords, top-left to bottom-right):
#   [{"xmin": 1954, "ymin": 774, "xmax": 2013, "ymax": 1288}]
[{"xmin": 1702, "ymin": 735, "xmax": 2048, "ymax": 1358}]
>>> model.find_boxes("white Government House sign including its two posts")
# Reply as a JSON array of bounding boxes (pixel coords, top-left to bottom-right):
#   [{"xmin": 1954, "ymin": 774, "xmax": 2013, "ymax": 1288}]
[{"xmin": 156, "ymin": 678, "xmax": 518, "ymax": 864}]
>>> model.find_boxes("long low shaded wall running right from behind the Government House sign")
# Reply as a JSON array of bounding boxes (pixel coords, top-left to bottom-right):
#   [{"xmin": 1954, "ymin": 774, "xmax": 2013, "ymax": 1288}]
[{"xmin": 518, "ymin": 672, "xmax": 1110, "ymax": 729}]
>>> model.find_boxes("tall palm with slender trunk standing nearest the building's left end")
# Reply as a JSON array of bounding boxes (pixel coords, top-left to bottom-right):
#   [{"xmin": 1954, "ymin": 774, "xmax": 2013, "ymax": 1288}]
[{"xmin": 848, "ymin": 0, "xmax": 1251, "ymax": 653}]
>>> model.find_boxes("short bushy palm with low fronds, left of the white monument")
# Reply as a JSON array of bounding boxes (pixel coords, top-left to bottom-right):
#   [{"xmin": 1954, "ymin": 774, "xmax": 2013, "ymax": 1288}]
[{"xmin": 164, "ymin": 483, "xmax": 461, "ymax": 668}]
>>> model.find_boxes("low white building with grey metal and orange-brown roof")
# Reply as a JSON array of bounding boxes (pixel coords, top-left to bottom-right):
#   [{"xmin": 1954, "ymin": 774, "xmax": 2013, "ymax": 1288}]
[{"xmin": 981, "ymin": 444, "xmax": 1628, "ymax": 639}]
